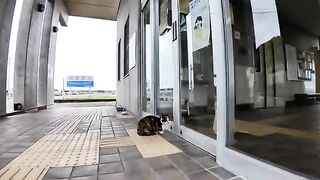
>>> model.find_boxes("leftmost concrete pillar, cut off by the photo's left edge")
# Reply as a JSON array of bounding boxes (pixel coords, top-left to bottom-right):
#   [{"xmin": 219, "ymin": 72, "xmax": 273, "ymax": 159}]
[{"xmin": 0, "ymin": 0, "xmax": 16, "ymax": 116}]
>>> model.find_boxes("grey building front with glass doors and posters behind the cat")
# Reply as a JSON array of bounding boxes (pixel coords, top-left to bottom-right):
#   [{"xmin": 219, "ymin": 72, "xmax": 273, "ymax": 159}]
[{"xmin": 117, "ymin": 0, "xmax": 320, "ymax": 179}]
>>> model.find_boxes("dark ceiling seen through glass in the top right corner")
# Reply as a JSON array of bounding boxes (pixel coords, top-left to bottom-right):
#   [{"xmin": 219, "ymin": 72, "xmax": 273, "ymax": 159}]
[{"xmin": 276, "ymin": 0, "xmax": 320, "ymax": 36}]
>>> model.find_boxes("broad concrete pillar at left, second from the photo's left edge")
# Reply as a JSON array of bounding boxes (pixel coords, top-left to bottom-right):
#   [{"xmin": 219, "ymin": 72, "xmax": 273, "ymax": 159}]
[{"xmin": 14, "ymin": 0, "xmax": 46, "ymax": 110}]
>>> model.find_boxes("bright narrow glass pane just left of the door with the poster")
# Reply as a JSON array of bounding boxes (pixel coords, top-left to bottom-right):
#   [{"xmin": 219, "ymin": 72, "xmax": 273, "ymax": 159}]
[{"xmin": 157, "ymin": 0, "xmax": 176, "ymax": 119}]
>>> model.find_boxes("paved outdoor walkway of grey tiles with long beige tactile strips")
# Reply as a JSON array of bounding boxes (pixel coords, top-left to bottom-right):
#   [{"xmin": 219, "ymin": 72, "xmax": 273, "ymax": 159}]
[{"xmin": 0, "ymin": 102, "xmax": 241, "ymax": 180}]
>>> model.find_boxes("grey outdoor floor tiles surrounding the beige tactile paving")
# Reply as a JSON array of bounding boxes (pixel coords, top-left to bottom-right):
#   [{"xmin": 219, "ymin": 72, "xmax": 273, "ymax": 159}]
[{"xmin": 0, "ymin": 103, "xmax": 237, "ymax": 180}]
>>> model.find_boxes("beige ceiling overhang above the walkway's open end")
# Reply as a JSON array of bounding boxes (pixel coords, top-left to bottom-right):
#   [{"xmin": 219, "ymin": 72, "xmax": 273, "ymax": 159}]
[{"xmin": 64, "ymin": 0, "xmax": 120, "ymax": 21}]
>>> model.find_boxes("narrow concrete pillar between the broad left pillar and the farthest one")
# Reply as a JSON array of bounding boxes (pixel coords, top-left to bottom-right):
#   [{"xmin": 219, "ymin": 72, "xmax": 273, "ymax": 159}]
[{"xmin": 38, "ymin": 1, "xmax": 53, "ymax": 107}]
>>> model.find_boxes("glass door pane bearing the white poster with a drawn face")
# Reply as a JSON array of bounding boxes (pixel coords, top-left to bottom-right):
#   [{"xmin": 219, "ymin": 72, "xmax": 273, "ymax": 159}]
[{"xmin": 180, "ymin": 0, "xmax": 216, "ymax": 138}]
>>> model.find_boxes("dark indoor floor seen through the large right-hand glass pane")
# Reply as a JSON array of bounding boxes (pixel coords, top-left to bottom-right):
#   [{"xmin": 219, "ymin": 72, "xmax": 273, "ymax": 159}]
[{"xmin": 234, "ymin": 103, "xmax": 320, "ymax": 179}]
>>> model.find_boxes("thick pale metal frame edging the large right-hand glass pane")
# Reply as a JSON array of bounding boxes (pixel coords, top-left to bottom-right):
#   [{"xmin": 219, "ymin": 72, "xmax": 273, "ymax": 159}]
[{"xmin": 218, "ymin": 0, "xmax": 305, "ymax": 180}]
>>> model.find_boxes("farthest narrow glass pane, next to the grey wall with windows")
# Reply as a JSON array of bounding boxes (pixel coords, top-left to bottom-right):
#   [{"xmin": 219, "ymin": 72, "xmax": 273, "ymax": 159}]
[{"xmin": 142, "ymin": 1, "xmax": 151, "ymax": 112}]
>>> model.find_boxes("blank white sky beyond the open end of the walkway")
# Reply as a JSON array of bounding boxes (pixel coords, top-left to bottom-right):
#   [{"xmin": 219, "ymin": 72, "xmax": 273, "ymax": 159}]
[{"xmin": 55, "ymin": 16, "xmax": 117, "ymax": 90}]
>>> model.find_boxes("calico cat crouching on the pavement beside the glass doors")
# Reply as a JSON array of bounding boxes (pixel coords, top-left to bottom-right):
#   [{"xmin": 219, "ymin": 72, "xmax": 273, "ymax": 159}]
[{"xmin": 137, "ymin": 114, "xmax": 169, "ymax": 136}]
